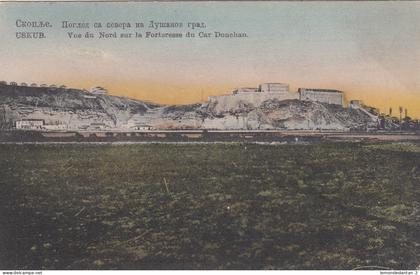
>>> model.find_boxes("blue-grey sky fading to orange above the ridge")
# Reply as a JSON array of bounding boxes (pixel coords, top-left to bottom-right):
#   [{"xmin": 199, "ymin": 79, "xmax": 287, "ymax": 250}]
[{"xmin": 0, "ymin": 1, "xmax": 420, "ymax": 118}]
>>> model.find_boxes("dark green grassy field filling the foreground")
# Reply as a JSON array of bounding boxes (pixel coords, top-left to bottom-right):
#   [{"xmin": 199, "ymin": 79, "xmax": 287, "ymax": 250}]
[{"xmin": 0, "ymin": 143, "xmax": 420, "ymax": 269}]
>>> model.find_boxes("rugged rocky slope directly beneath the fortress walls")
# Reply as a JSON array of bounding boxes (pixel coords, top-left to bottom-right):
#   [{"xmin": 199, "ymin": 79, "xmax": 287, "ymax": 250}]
[{"xmin": 195, "ymin": 99, "xmax": 377, "ymax": 130}]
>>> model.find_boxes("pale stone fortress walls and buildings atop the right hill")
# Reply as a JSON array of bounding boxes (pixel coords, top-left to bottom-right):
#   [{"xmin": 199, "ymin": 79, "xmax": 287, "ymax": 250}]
[{"xmin": 209, "ymin": 83, "xmax": 344, "ymax": 108}]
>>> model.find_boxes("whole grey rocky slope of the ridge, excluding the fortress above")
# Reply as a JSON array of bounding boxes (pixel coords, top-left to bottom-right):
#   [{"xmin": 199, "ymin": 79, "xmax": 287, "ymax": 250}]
[{"xmin": 0, "ymin": 85, "xmax": 377, "ymax": 130}]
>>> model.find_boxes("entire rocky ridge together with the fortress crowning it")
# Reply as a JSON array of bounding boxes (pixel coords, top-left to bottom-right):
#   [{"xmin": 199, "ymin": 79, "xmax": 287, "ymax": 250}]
[{"xmin": 0, "ymin": 81, "xmax": 399, "ymax": 131}]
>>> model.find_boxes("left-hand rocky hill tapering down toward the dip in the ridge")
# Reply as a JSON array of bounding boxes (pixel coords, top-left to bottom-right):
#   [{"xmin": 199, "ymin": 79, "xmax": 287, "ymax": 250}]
[{"xmin": 0, "ymin": 86, "xmax": 158, "ymax": 129}]
